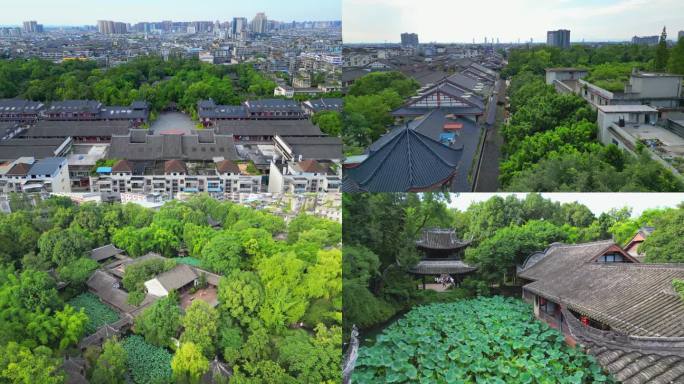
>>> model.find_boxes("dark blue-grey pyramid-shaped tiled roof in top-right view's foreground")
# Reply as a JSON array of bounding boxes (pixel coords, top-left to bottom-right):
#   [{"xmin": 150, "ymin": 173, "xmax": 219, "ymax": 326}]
[{"xmin": 345, "ymin": 127, "xmax": 462, "ymax": 192}]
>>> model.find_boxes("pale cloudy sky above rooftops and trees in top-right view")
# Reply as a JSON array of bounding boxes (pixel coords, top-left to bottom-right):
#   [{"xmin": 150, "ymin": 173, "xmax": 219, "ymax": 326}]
[{"xmin": 341, "ymin": 0, "xmax": 684, "ymax": 43}]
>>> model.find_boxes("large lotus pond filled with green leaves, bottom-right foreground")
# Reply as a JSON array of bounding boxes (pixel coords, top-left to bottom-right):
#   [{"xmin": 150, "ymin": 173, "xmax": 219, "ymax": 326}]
[{"xmin": 353, "ymin": 296, "xmax": 613, "ymax": 384}]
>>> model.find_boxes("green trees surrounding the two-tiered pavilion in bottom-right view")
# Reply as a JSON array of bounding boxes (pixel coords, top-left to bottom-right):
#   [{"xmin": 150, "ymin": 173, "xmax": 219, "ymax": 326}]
[{"xmin": 342, "ymin": 193, "xmax": 608, "ymax": 334}]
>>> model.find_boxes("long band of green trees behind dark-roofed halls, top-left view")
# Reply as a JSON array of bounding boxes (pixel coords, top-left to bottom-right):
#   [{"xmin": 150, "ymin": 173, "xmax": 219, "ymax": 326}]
[{"xmin": 0, "ymin": 57, "xmax": 275, "ymax": 115}]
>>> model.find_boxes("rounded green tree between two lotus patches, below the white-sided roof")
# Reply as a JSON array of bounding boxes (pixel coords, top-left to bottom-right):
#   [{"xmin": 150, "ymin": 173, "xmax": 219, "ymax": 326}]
[{"xmin": 133, "ymin": 294, "xmax": 181, "ymax": 347}]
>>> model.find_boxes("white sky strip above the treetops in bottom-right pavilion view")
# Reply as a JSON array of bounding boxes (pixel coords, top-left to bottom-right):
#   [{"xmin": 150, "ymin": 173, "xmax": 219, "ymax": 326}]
[{"xmin": 450, "ymin": 193, "xmax": 684, "ymax": 217}]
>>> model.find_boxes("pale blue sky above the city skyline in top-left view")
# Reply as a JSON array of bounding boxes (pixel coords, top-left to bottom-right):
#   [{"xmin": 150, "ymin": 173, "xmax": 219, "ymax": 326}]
[{"xmin": 0, "ymin": 0, "xmax": 342, "ymax": 25}]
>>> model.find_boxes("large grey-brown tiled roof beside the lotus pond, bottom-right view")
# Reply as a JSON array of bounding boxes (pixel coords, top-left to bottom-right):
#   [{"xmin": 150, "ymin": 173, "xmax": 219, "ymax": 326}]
[{"xmin": 518, "ymin": 241, "xmax": 684, "ymax": 337}]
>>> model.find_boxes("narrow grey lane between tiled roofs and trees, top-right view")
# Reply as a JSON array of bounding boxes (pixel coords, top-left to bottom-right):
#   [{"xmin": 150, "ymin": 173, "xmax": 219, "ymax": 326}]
[{"xmin": 475, "ymin": 80, "xmax": 506, "ymax": 192}]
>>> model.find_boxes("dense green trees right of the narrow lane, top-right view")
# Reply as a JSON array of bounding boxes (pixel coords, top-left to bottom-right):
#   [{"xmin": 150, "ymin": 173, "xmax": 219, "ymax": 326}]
[{"xmin": 499, "ymin": 70, "xmax": 684, "ymax": 192}]
